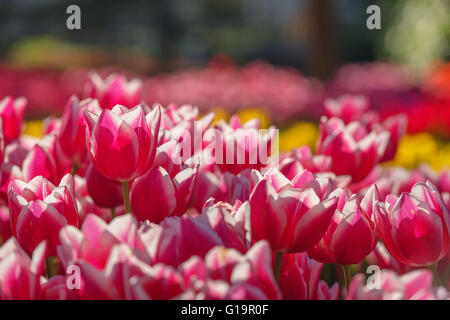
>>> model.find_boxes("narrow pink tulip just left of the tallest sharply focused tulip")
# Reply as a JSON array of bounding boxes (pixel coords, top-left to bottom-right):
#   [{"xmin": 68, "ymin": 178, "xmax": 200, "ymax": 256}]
[{"xmin": 58, "ymin": 96, "xmax": 101, "ymax": 167}]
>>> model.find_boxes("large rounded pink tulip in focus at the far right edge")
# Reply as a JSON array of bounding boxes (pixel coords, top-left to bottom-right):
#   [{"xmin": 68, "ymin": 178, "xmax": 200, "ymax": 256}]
[{"xmin": 374, "ymin": 181, "xmax": 450, "ymax": 266}]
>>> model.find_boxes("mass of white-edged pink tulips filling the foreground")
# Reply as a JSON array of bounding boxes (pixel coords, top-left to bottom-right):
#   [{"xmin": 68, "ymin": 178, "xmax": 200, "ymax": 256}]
[{"xmin": 0, "ymin": 75, "xmax": 450, "ymax": 299}]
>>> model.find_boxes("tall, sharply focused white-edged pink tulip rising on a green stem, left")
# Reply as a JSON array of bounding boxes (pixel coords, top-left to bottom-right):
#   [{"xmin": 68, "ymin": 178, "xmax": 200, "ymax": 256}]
[{"xmin": 85, "ymin": 105, "xmax": 161, "ymax": 182}]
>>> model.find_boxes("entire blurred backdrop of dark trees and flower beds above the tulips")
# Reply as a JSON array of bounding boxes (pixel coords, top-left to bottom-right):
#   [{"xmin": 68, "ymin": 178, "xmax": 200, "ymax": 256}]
[{"xmin": 0, "ymin": 0, "xmax": 450, "ymax": 168}]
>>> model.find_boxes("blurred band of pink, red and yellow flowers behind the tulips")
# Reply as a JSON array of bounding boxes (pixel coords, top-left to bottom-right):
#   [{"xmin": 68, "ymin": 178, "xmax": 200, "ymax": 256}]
[{"xmin": 0, "ymin": 58, "xmax": 450, "ymax": 170}]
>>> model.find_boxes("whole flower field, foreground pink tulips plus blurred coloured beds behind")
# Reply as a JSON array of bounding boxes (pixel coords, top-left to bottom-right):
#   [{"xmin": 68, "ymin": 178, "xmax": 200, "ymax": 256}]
[{"xmin": 0, "ymin": 63, "xmax": 450, "ymax": 300}]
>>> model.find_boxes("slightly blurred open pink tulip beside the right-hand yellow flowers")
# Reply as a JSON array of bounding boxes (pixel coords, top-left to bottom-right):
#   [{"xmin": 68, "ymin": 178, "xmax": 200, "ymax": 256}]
[{"xmin": 317, "ymin": 118, "xmax": 389, "ymax": 182}]
